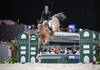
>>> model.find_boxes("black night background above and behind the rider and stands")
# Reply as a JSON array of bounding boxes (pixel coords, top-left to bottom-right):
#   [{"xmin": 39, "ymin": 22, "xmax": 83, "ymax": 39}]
[{"xmin": 0, "ymin": 0, "xmax": 100, "ymax": 31}]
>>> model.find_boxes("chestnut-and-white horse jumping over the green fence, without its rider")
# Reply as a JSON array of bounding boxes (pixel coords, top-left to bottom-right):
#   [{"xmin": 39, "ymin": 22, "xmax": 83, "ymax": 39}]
[{"xmin": 37, "ymin": 12, "xmax": 66, "ymax": 45}]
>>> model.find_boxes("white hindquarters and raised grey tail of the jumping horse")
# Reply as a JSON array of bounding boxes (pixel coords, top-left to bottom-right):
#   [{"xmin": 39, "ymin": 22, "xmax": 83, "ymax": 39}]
[{"xmin": 42, "ymin": 12, "xmax": 66, "ymax": 33}]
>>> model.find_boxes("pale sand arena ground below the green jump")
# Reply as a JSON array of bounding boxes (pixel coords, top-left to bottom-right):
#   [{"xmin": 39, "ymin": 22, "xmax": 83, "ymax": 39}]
[{"xmin": 0, "ymin": 63, "xmax": 100, "ymax": 70}]
